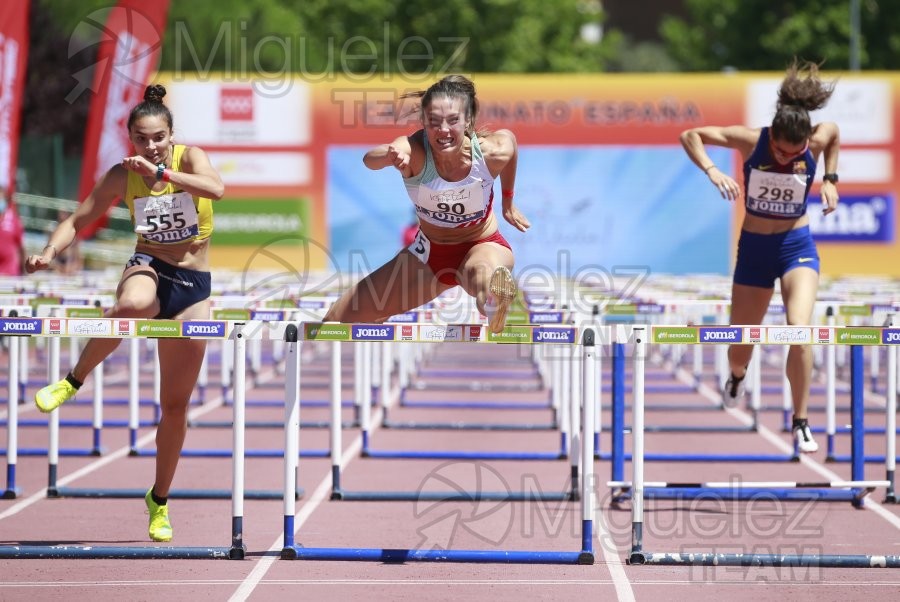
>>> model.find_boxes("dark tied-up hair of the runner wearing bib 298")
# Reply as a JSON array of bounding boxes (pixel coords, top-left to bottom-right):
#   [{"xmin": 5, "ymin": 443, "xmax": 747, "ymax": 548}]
[{"xmin": 772, "ymin": 59, "xmax": 835, "ymax": 144}]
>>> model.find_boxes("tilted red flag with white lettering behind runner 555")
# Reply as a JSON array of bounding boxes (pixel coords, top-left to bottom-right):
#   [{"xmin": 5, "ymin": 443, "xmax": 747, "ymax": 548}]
[{"xmin": 69, "ymin": 0, "xmax": 169, "ymax": 238}]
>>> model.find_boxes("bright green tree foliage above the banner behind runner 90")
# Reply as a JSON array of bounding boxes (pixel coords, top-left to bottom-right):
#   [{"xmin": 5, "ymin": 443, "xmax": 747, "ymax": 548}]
[{"xmin": 161, "ymin": 0, "xmax": 618, "ymax": 78}]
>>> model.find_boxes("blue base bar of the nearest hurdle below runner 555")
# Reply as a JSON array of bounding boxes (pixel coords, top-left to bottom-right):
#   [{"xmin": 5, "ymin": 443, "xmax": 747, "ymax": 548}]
[{"xmin": 0, "ymin": 545, "xmax": 244, "ymax": 560}]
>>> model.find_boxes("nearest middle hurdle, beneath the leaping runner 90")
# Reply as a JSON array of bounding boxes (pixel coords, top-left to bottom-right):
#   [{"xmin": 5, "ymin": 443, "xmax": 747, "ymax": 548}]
[{"xmin": 281, "ymin": 324, "xmax": 597, "ymax": 564}]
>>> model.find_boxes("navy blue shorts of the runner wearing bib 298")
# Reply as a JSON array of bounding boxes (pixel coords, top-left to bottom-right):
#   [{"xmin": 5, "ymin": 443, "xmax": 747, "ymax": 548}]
[{"xmin": 734, "ymin": 226, "xmax": 819, "ymax": 288}]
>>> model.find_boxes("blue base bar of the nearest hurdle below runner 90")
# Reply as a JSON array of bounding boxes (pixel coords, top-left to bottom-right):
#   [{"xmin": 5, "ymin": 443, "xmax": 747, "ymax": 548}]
[{"xmin": 281, "ymin": 545, "xmax": 594, "ymax": 564}]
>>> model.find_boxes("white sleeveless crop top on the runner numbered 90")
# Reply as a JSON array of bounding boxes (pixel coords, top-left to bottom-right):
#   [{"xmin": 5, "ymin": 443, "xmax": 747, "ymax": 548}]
[{"xmin": 403, "ymin": 133, "xmax": 494, "ymax": 228}]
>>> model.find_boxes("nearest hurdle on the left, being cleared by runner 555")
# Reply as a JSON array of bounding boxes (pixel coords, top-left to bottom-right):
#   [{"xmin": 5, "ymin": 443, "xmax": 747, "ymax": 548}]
[{"xmin": 0, "ymin": 318, "xmax": 256, "ymax": 560}]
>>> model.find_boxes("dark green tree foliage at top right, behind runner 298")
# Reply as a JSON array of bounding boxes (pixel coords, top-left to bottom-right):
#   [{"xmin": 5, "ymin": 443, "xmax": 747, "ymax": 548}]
[{"xmin": 660, "ymin": 0, "xmax": 900, "ymax": 71}]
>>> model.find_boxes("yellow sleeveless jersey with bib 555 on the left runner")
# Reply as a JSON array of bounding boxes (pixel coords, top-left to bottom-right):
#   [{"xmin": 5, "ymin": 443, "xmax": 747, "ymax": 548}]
[{"xmin": 125, "ymin": 144, "xmax": 213, "ymax": 245}]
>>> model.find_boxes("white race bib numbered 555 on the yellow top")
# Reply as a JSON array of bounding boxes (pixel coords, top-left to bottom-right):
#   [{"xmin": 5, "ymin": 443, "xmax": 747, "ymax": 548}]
[{"xmin": 134, "ymin": 192, "xmax": 200, "ymax": 243}]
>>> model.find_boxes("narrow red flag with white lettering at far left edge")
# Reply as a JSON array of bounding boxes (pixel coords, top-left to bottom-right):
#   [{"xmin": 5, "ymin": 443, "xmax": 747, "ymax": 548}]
[{"xmin": 0, "ymin": 0, "xmax": 29, "ymax": 199}]
